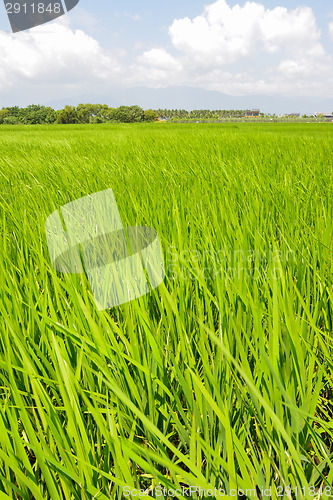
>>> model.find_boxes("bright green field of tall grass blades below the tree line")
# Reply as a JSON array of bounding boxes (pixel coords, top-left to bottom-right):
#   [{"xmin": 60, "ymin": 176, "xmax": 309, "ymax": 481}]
[{"xmin": 0, "ymin": 123, "xmax": 333, "ymax": 500}]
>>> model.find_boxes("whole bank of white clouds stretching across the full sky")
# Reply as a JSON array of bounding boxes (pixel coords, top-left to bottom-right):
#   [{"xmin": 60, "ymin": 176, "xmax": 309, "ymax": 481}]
[{"xmin": 0, "ymin": 0, "xmax": 333, "ymax": 96}]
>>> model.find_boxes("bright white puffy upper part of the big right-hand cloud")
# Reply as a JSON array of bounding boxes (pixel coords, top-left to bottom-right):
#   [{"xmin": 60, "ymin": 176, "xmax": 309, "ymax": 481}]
[{"xmin": 169, "ymin": 0, "xmax": 321, "ymax": 66}]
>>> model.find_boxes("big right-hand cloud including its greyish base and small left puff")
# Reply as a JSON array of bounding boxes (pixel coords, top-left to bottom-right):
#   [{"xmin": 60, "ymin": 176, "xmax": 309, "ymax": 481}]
[{"xmin": 137, "ymin": 0, "xmax": 333, "ymax": 95}]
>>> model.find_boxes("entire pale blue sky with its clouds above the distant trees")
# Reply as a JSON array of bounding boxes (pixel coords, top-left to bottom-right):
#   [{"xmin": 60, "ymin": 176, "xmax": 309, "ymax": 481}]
[{"xmin": 0, "ymin": 0, "xmax": 333, "ymax": 113}]
